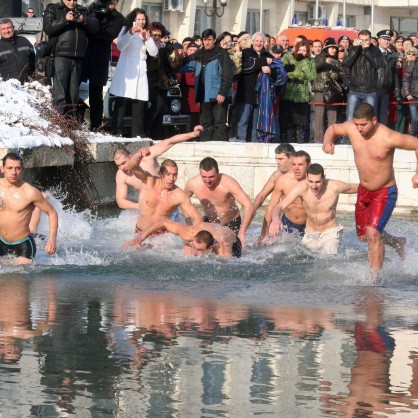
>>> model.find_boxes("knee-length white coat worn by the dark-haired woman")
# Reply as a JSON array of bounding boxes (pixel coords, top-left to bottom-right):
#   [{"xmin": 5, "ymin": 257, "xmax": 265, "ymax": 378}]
[{"xmin": 109, "ymin": 26, "xmax": 158, "ymax": 101}]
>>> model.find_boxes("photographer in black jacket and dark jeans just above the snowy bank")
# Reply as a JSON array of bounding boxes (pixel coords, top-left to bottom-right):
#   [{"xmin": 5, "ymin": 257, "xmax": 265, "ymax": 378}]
[{"xmin": 43, "ymin": 0, "xmax": 99, "ymax": 117}]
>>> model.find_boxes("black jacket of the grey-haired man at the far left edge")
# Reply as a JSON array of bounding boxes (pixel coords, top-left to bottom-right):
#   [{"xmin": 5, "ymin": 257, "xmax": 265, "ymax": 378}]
[{"xmin": 0, "ymin": 35, "xmax": 35, "ymax": 84}]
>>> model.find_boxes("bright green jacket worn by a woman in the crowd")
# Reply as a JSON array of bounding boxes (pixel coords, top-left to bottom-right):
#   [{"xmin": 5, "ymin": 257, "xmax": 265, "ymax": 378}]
[{"xmin": 282, "ymin": 53, "xmax": 316, "ymax": 103}]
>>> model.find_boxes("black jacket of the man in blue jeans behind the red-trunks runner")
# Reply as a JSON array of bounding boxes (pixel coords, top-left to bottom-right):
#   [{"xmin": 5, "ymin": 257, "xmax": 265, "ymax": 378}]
[{"xmin": 343, "ymin": 45, "xmax": 386, "ymax": 93}]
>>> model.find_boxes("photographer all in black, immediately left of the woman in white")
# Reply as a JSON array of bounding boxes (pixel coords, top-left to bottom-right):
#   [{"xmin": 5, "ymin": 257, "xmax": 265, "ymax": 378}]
[{"xmin": 81, "ymin": 0, "xmax": 125, "ymax": 131}]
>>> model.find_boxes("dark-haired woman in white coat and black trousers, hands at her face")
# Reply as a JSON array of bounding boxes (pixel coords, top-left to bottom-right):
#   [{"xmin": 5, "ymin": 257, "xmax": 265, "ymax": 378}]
[{"xmin": 109, "ymin": 8, "xmax": 158, "ymax": 138}]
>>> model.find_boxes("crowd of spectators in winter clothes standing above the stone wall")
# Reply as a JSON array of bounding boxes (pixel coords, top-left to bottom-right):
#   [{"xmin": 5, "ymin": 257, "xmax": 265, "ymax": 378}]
[{"xmin": 0, "ymin": 0, "xmax": 418, "ymax": 143}]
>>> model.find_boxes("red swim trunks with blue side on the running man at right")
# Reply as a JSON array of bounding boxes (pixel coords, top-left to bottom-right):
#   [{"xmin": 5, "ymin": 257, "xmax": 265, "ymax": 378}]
[{"xmin": 355, "ymin": 186, "xmax": 398, "ymax": 237}]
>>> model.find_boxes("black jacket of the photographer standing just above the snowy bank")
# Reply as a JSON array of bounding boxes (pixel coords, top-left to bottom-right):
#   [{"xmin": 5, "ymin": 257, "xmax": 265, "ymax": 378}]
[{"xmin": 43, "ymin": 3, "xmax": 99, "ymax": 58}]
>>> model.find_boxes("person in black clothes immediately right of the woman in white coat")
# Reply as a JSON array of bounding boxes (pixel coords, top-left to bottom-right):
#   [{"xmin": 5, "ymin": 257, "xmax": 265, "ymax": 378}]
[{"xmin": 145, "ymin": 22, "xmax": 181, "ymax": 140}]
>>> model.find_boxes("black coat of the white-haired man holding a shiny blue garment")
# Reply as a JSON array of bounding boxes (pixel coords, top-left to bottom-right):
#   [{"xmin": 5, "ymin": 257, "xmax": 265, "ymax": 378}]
[{"xmin": 235, "ymin": 47, "xmax": 274, "ymax": 106}]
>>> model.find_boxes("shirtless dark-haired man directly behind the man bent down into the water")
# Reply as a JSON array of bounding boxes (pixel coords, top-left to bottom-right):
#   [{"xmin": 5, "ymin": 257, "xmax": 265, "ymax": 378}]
[{"xmin": 184, "ymin": 157, "xmax": 254, "ymax": 257}]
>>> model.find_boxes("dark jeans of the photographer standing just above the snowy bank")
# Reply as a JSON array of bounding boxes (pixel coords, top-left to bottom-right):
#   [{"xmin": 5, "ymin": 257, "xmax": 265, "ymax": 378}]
[{"xmin": 52, "ymin": 57, "xmax": 82, "ymax": 116}]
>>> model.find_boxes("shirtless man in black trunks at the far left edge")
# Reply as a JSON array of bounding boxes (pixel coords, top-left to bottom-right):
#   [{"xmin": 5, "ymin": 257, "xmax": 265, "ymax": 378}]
[{"xmin": 0, "ymin": 152, "xmax": 58, "ymax": 265}]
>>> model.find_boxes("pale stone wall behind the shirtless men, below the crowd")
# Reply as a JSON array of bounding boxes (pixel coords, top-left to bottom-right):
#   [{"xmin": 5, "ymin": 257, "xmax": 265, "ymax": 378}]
[{"xmin": 0, "ymin": 138, "xmax": 418, "ymax": 216}]
